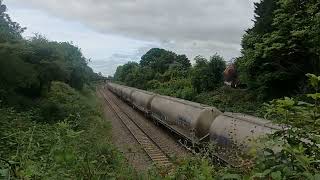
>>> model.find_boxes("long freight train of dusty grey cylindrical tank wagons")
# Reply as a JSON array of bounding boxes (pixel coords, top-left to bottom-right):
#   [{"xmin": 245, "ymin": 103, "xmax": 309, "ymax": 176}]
[{"xmin": 106, "ymin": 82, "xmax": 281, "ymax": 149}]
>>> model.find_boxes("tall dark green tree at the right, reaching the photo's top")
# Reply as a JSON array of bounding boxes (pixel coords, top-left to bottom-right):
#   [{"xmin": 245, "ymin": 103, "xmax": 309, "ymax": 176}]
[{"xmin": 237, "ymin": 0, "xmax": 320, "ymax": 98}]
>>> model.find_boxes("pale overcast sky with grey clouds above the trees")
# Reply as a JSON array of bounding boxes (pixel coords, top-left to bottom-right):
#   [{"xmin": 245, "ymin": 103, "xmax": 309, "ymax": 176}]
[{"xmin": 4, "ymin": 0, "xmax": 258, "ymax": 75}]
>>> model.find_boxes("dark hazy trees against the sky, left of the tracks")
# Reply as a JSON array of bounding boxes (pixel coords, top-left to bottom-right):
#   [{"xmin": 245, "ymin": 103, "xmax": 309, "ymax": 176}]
[{"xmin": 0, "ymin": 1, "xmax": 101, "ymax": 107}]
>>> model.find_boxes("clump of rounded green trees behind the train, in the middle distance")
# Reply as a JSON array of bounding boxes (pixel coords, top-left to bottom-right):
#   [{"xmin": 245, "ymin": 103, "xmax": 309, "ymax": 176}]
[{"xmin": 114, "ymin": 48, "xmax": 226, "ymax": 100}]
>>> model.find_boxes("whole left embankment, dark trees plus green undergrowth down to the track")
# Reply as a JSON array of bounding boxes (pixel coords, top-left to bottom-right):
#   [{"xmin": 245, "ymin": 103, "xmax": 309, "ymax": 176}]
[{"xmin": 0, "ymin": 1, "xmax": 137, "ymax": 179}]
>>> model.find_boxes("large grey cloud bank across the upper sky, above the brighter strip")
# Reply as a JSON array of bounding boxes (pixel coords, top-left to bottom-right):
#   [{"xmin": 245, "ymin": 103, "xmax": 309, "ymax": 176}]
[{"xmin": 10, "ymin": 0, "xmax": 254, "ymax": 59}]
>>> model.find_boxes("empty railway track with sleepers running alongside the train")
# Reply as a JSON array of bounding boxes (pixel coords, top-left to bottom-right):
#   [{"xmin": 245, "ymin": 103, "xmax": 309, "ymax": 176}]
[{"xmin": 99, "ymin": 90, "xmax": 173, "ymax": 167}]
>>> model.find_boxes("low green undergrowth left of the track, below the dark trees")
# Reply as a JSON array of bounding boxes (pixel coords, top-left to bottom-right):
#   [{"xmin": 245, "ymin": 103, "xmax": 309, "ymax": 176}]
[{"xmin": 0, "ymin": 82, "xmax": 135, "ymax": 179}]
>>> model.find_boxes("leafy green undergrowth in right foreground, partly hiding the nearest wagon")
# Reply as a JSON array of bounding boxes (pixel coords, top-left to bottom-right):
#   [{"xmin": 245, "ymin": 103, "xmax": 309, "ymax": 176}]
[{"xmin": 151, "ymin": 74, "xmax": 320, "ymax": 180}]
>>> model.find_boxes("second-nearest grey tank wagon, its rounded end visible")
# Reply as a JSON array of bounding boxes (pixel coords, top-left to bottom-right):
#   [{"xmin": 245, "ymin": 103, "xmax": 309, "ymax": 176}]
[{"xmin": 150, "ymin": 95, "xmax": 221, "ymax": 142}]
